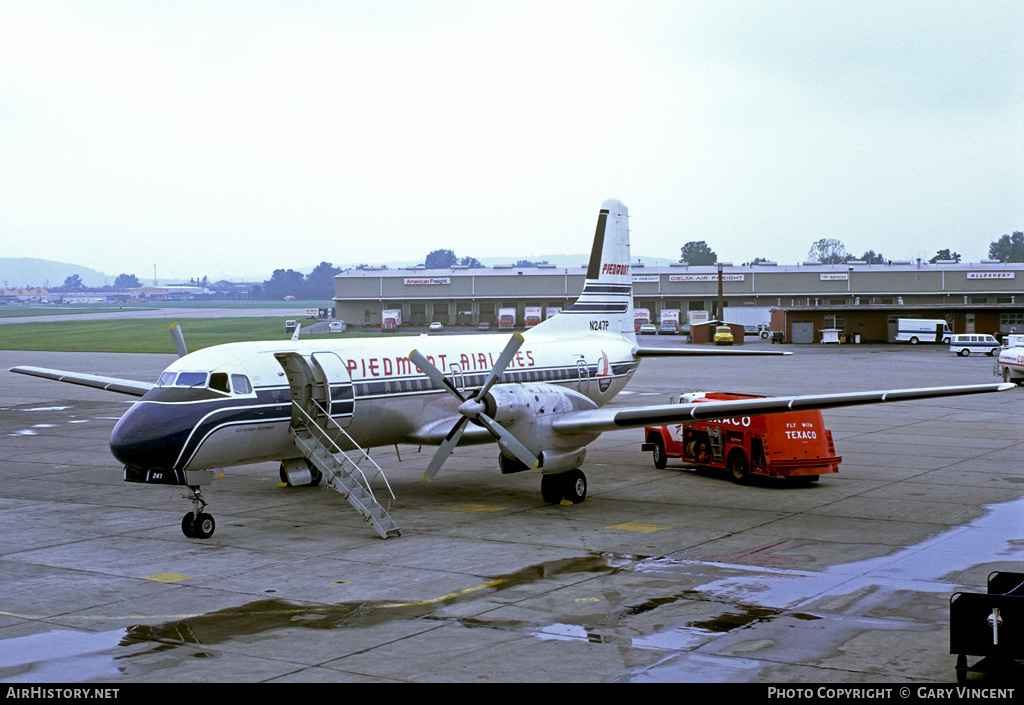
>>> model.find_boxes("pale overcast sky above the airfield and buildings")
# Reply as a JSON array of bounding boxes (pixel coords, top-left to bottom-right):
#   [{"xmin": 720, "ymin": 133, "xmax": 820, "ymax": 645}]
[{"xmin": 0, "ymin": 0, "xmax": 1024, "ymax": 281}]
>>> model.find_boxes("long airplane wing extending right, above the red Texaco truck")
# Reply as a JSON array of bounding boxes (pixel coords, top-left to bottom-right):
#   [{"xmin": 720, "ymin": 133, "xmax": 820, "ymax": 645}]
[{"xmin": 552, "ymin": 383, "xmax": 1016, "ymax": 434}]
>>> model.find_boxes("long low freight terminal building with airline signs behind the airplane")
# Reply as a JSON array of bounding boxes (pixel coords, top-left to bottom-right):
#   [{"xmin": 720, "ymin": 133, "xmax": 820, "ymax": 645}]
[{"xmin": 335, "ymin": 260, "xmax": 1024, "ymax": 343}]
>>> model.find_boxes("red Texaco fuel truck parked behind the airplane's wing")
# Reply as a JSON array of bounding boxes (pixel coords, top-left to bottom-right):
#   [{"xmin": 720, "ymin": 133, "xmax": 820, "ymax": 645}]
[{"xmin": 641, "ymin": 391, "xmax": 843, "ymax": 483}]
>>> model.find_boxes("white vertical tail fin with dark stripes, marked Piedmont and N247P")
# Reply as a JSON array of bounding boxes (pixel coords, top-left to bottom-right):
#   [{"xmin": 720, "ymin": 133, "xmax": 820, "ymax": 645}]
[{"xmin": 531, "ymin": 199, "xmax": 636, "ymax": 341}]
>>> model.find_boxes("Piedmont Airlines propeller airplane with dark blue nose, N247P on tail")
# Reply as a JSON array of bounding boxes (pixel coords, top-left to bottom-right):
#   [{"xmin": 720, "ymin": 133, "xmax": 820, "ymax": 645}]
[{"xmin": 10, "ymin": 199, "xmax": 1014, "ymax": 539}]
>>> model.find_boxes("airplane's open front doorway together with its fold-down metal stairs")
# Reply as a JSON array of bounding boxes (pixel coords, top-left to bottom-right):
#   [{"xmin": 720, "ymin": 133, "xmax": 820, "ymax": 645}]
[{"xmin": 274, "ymin": 353, "xmax": 401, "ymax": 539}]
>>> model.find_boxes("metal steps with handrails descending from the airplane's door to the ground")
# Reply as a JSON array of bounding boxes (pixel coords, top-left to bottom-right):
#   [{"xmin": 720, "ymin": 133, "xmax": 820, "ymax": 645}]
[{"xmin": 289, "ymin": 402, "xmax": 401, "ymax": 539}]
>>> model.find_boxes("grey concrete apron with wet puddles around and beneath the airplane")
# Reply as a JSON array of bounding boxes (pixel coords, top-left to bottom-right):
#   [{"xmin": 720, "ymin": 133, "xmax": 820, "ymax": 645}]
[{"xmin": 0, "ymin": 339, "xmax": 1024, "ymax": 683}]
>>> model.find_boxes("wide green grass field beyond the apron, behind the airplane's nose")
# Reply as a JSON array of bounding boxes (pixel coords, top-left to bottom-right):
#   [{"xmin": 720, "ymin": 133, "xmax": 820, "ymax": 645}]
[{"xmin": 0, "ymin": 316, "xmax": 368, "ymax": 355}]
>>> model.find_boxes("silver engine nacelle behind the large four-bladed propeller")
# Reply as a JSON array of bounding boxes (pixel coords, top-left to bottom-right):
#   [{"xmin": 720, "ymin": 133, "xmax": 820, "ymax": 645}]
[{"xmin": 484, "ymin": 383, "xmax": 600, "ymax": 465}]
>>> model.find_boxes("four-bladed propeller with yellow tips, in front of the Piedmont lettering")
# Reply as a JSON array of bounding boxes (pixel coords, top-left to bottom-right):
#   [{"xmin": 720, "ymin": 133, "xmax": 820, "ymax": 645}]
[{"xmin": 409, "ymin": 333, "xmax": 541, "ymax": 483}]
